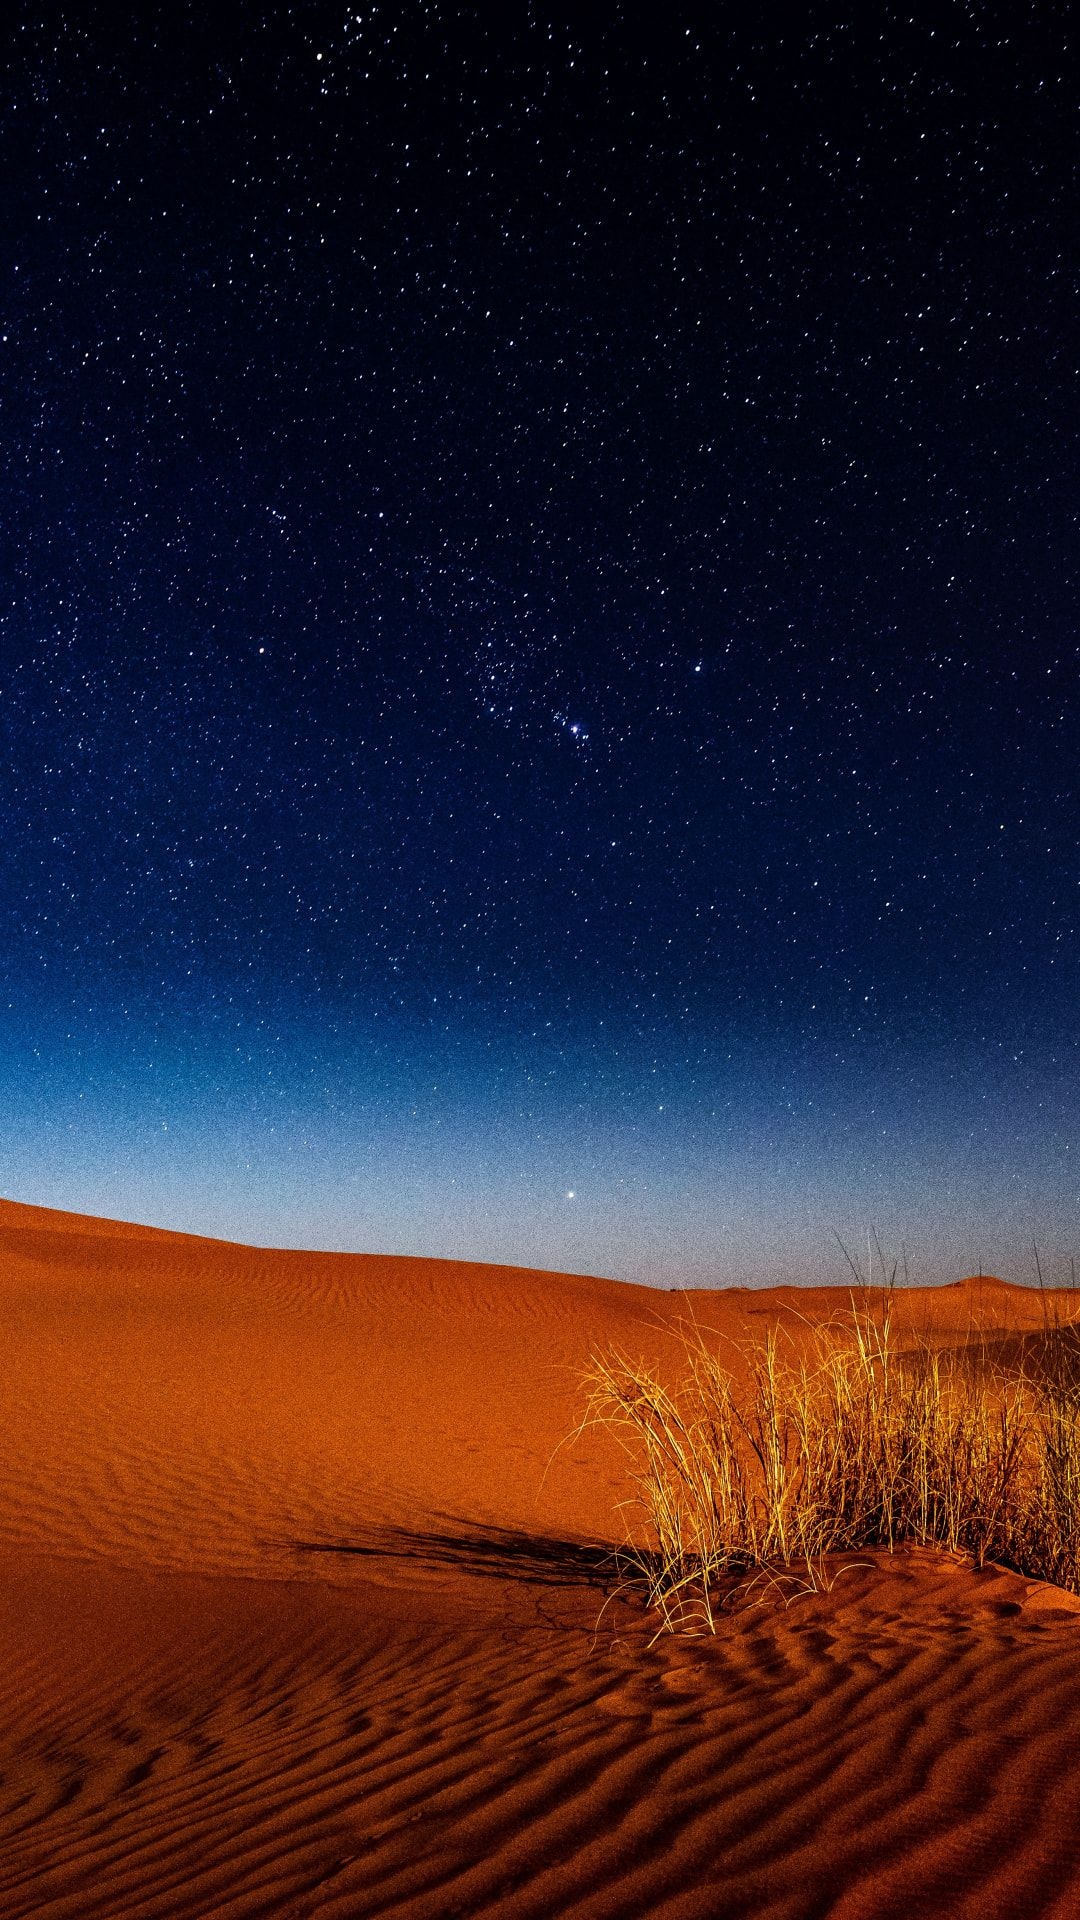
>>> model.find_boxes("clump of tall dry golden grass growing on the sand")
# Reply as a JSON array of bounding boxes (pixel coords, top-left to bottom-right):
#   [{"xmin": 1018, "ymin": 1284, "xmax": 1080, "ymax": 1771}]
[{"xmin": 586, "ymin": 1292, "xmax": 1080, "ymax": 1630}]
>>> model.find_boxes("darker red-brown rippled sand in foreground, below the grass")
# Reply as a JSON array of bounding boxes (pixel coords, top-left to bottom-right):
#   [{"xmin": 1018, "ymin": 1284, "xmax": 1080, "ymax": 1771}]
[{"xmin": 0, "ymin": 1563, "xmax": 1080, "ymax": 1920}]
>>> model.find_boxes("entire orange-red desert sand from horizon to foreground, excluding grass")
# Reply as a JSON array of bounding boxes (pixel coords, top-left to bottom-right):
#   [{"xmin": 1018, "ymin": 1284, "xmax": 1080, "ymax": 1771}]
[{"xmin": 0, "ymin": 1202, "xmax": 1080, "ymax": 1920}]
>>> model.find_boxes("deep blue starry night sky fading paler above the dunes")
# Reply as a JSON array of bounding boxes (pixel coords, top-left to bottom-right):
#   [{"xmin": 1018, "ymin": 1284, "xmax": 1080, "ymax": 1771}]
[{"xmin": 0, "ymin": 0, "xmax": 1080, "ymax": 1286}]
